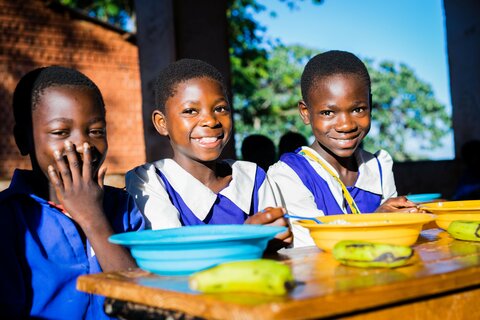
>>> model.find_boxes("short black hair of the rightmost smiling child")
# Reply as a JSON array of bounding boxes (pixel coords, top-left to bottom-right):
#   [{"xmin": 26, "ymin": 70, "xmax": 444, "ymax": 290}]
[{"xmin": 301, "ymin": 50, "xmax": 371, "ymax": 105}]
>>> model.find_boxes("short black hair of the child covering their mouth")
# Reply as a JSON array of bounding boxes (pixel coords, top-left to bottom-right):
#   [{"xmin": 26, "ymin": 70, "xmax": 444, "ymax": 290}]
[{"xmin": 12, "ymin": 66, "xmax": 105, "ymax": 129}]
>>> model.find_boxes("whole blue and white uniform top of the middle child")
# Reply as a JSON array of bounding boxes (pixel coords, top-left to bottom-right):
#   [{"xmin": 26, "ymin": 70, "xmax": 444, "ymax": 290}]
[{"xmin": 126, "ymin": 159, "xmax": 277, "ymax": 229}]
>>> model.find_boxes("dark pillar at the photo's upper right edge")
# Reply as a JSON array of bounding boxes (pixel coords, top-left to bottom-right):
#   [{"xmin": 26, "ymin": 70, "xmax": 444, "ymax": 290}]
[{"xmin": 444, "ymin": 0, "xmax": 480, "ymax": 157}]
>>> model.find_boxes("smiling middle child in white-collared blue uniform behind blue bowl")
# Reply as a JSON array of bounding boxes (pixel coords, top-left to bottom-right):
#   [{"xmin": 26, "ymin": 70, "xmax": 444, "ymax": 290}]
[{"xmin": 126, "ymin": 59, "xmax": 292, "ymax": 245}]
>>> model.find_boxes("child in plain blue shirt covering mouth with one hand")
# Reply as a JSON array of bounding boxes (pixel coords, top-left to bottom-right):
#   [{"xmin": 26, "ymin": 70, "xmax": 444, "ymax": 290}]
[{"xmin": 0, "ymin": 66, "xmax": 145, "ymax": 319}]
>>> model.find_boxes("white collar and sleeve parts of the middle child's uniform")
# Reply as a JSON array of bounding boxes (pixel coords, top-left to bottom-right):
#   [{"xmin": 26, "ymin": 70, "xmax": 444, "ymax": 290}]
[{"xmin": 126, "ymin": 159, "xmax": 279, "ymax": 230}]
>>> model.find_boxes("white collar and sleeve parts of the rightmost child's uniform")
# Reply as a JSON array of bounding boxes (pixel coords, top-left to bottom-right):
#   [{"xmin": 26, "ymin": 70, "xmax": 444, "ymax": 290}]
[{"xmin": 268, "ymin": 147, "xmax": 397, "ymax": 247}]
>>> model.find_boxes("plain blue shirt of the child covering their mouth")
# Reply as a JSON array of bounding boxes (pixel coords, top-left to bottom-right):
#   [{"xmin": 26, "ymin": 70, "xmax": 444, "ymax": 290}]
[{"xmin": 0, "ymin": 170, "xmax": 145, "ymax": 319}]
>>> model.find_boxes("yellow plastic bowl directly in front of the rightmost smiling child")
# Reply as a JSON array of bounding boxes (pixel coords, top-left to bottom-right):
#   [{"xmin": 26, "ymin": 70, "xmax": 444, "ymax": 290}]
[{"xmin": 293, "ymin": 213, "xmax": 435, "ymax": 252}]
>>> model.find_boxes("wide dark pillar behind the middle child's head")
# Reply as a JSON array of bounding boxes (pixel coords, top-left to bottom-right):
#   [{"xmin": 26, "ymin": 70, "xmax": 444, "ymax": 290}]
[{"xmin": 135, "ymin": 0, "xmax": 235, "ymax": 161}]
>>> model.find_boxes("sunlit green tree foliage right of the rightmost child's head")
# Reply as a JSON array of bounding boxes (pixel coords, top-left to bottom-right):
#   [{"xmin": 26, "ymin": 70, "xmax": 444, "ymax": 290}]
[{"xmin": 364, "ymin": 60, "xmax": 451, "ymax": 161}]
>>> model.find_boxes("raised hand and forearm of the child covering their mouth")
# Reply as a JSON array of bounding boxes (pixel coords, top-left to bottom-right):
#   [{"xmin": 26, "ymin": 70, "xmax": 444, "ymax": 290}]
[{"xmin": 48, "ymin": 142, "xmax": 136, "ymax": 271}]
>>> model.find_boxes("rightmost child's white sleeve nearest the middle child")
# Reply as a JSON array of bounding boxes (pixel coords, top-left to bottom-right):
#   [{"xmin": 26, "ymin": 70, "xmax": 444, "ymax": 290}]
[{"xmin": 268, "ymin": 161, "xmax": 324, "ymax": 247}]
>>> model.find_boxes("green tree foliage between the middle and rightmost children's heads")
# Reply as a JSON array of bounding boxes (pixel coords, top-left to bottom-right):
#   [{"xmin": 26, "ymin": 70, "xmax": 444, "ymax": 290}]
[{"xmin": 234, "ymin": 45, "xmax": 317, "ymax": 148}]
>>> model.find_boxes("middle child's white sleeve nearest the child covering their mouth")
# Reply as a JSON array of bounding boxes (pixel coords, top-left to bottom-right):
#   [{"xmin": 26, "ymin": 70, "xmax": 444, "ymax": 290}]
[{"xmin": 125, "ymin": 164, "xmax": 182, "ymax": 230}]
